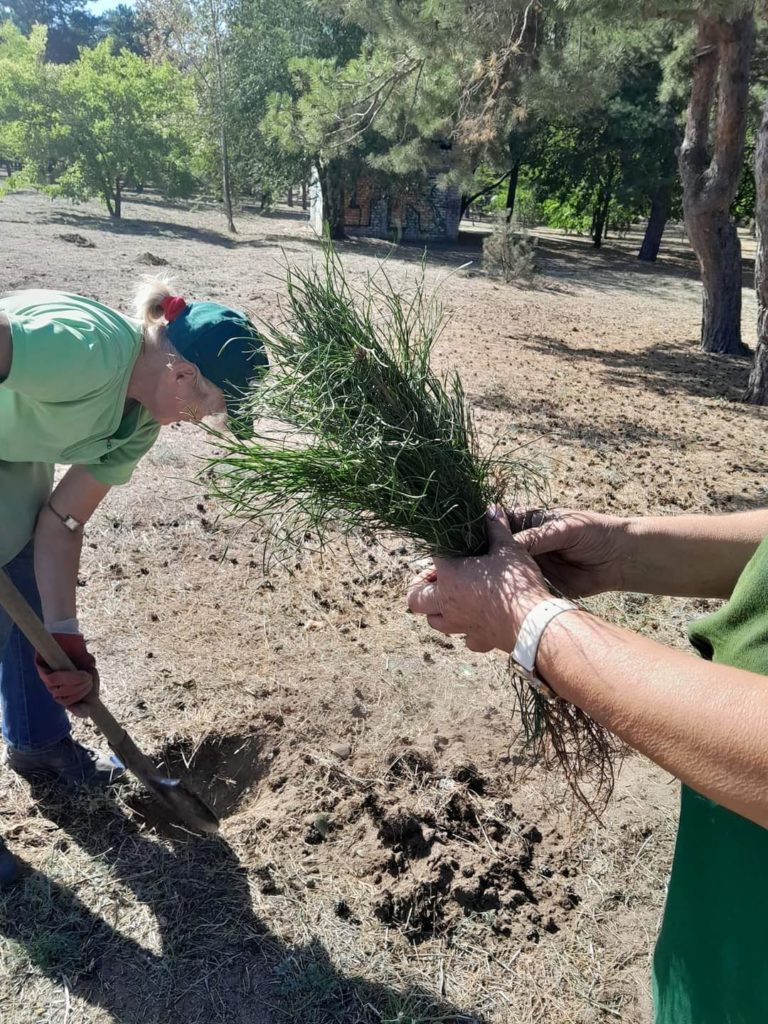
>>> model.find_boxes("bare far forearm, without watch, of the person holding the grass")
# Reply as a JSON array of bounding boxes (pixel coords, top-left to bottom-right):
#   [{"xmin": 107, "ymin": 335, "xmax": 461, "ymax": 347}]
[{"xmin": 621, "ymin": 509, "xmax": 768, "ymax": 598}]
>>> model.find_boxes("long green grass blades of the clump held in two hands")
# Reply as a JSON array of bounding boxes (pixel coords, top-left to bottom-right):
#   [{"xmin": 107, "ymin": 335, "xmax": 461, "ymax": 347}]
[{"xmin": 207, "ymin": 252, "xmax": 538, "ymax": 554}]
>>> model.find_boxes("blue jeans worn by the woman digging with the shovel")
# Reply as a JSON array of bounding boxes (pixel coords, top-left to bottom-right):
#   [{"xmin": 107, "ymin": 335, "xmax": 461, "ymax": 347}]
[{"xmin": 0, "ymin": 542, "xmax": 70, "ymax": 753}]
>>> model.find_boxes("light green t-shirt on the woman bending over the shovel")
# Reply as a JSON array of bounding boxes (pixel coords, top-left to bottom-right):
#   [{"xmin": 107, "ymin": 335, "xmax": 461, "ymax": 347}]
[{"xmin": 0, "ymin": 290, "xmax": 160, "ymax": 565}]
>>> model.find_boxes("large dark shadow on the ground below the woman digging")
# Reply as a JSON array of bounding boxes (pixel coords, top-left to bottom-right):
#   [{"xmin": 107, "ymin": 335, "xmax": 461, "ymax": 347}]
[{"xmin": 0, "ymin": 757, "xmax": 482, "ymax": 1024}]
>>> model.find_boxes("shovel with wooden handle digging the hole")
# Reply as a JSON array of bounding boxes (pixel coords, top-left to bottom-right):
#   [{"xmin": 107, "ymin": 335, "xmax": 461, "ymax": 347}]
[{"xmin": 0, "ymin": 568, "xmax": 219, "ymax": 833}]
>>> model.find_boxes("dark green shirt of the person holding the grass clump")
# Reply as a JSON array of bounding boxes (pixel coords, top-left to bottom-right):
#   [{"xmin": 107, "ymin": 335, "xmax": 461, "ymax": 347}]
[{"xmin": 653, "ymin": 539, "xmax": 768, "ymax": 1024}]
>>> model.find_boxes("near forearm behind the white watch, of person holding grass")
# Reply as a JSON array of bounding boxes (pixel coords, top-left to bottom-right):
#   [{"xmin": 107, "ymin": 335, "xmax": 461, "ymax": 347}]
[{"xmin": 537, "ymin": 611, "xmax": 768, "ymax": 827}]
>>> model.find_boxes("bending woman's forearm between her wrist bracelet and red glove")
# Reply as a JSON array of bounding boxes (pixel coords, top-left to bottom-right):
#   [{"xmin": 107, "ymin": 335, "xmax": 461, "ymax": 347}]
[{"xmin": 35, "ymin": 508, "xmax": 83, "ymax": 626}]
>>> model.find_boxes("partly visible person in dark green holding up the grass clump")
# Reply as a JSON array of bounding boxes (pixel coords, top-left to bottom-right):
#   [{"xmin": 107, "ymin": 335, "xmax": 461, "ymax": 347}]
[{"xmin": 409, "ymin": 510, "xmax": 768, "ymax": 1024}]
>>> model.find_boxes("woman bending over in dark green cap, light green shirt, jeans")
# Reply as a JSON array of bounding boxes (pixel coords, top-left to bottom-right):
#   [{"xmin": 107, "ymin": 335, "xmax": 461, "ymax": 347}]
[{"xmin": 0, "ymin": 281, "xmax": 266, "ymax": 886}]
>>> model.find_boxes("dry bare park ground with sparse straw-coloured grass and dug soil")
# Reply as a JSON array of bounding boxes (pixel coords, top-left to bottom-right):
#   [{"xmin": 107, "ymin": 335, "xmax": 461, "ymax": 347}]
[{"xmin": 0, "ymin": 194, "xmax": 768, "ymax": 1024}]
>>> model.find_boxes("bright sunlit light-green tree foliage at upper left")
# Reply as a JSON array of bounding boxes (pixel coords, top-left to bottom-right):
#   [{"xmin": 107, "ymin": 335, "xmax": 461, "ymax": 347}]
[{"xmin": 0, "ymin": 26, "xmax": 195, "ymax": 216}]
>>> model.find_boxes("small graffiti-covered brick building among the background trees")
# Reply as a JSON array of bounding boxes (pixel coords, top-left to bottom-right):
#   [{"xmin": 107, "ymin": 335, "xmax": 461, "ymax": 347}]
[{"xmin": 309, "ymin": 175, "xmax": 461, "ymax": 242}]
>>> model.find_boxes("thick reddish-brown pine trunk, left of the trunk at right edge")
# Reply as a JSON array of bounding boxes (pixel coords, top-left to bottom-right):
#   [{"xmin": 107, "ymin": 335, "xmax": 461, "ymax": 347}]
[{"xmin": 679, "ymin": 10, "xmax": 755, "ymax": 355}]
